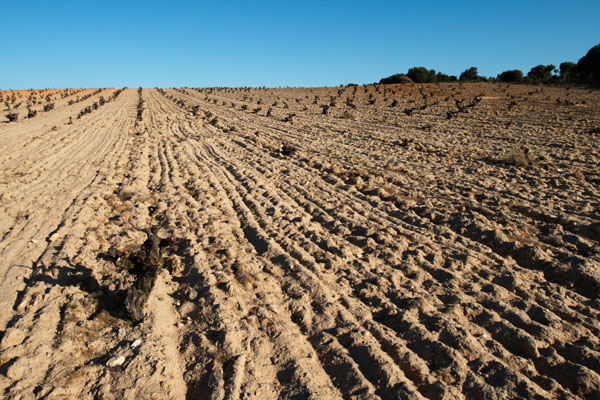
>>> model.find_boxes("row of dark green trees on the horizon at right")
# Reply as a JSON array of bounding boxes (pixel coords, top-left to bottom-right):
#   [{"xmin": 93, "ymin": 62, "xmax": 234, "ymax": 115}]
[{"xmin": 379, "ymin": 44, "xmax": 600, "ymax": 85}]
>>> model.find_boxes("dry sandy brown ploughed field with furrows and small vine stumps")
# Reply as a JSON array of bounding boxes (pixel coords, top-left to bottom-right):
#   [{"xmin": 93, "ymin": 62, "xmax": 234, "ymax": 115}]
[{"xmin": 0, "ymin": 83, "xmax": 600, "ymax": 399}]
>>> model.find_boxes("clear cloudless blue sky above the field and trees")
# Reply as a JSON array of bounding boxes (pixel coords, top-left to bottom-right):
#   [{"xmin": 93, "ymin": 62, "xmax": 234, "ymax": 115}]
[{"xmin": 0, "ymin": 0, "xmax": 600, "ymax": 89}]
